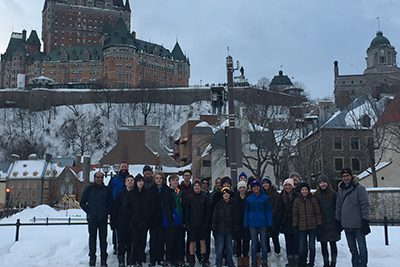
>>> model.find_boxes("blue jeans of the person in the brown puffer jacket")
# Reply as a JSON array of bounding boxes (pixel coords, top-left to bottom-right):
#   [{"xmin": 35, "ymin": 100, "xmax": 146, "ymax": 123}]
[{"xmin": 299, "ymin": 229, "xmax": 317, "ymax": 266}]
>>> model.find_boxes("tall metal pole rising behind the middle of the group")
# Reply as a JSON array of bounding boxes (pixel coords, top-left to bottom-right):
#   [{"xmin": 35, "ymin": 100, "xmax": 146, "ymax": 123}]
[{"xmin": 226, "ymin": 56, "xmax": 237, "ymax": 186}]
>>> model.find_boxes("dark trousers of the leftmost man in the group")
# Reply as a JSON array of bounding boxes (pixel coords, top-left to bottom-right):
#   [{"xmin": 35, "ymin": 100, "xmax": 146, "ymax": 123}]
[{"xmin": 88, "ymin": 219, "xmax": 107, "ymax": 260}]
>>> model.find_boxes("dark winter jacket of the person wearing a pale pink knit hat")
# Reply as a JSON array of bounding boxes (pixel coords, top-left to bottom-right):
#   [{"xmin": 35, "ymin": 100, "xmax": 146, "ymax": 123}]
[{"xmin": 279, "ymin": 190, "xmax": 299, "ymax": 234}]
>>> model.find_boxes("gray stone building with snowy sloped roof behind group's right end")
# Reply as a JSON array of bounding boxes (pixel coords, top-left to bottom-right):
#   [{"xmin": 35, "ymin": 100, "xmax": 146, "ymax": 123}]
[{"xmin": 296, "ymin": 96, "xmax": 381, "ymax": 188}]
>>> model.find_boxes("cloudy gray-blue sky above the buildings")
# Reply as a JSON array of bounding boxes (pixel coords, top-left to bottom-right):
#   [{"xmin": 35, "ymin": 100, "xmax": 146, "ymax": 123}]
[{"xmin": 0, "ymin": 0, "xmax": 400, "ymax": 98}]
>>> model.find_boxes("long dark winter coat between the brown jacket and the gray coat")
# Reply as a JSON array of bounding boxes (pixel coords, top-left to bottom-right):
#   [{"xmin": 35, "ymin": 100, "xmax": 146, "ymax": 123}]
[{"xmin": 315, "ymin": 189, "xmax": 340, "ymax": 242}]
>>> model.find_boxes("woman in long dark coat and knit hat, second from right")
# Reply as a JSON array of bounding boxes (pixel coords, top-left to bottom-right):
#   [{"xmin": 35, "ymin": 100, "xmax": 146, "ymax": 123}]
[{"xmin": 314, "ymin": 174, "xmax": 340, "ymax": 267}]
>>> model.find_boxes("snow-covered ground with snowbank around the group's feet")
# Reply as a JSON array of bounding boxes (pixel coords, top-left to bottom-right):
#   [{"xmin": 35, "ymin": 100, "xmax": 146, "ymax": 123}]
[{"xmin": 0, "ymin": 205, "xmax": 400, "ymax": 267}]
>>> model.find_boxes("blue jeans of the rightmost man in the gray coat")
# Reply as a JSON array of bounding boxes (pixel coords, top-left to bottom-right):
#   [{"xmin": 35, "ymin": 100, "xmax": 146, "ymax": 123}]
[{"xmin": 344, "ymin": 228, "xmax": 368, "ymax": 267}]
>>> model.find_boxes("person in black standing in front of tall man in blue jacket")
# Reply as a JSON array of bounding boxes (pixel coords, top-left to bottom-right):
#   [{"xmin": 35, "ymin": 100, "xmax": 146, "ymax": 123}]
[{"xmin": 112, "ymin": 175, "xmax": 134, "ymax": 267}]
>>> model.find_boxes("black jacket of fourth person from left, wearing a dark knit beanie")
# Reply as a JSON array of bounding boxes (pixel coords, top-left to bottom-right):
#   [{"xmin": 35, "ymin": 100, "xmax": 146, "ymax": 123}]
[{"xmin": 128, "ymin": 187, "xmax": 152, "ymax": 227}]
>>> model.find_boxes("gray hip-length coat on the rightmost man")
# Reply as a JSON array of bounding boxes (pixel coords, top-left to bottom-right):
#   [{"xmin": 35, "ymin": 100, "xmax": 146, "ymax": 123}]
[{"xmin": 336, "ymin": 178, "xmax": 369, "ymax": 228}]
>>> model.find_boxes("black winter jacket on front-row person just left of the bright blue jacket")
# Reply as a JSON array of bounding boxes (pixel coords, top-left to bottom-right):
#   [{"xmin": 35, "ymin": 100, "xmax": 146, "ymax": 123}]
[{"xmin": 211, "ymin": 199, "xmax": 234, "ymax": 234}]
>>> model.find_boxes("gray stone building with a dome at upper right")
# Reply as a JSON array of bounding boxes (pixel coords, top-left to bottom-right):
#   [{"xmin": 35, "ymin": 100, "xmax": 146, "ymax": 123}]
[{"xmin": 334, "ymin": 31, "xmax": 400, "ymax": 108}]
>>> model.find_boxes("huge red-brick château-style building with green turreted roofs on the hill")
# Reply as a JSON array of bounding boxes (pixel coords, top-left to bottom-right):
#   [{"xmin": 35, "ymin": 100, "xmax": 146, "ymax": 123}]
[{"xmin": 0, "ymin": 0, "xmax": 190, "ymax": 88}]
